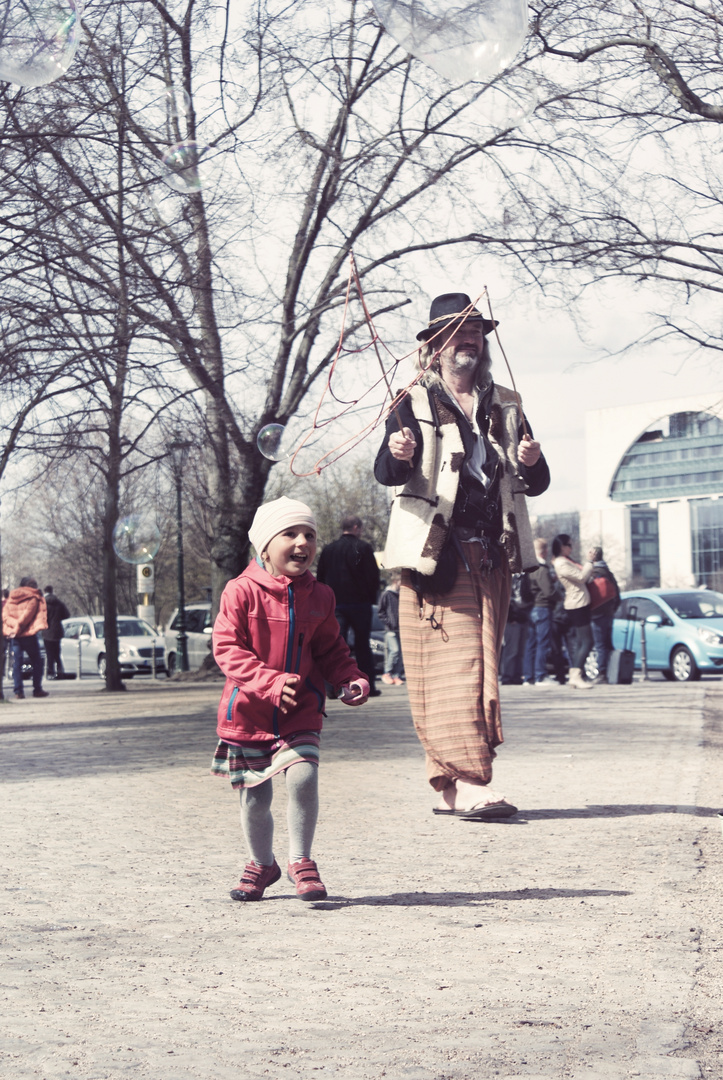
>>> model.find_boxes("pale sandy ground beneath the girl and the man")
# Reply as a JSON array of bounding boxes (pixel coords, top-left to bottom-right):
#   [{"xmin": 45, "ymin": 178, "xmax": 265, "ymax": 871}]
[{"xmin": 0, "ymin": 680, "xmax": 723, "ymax": 1080}]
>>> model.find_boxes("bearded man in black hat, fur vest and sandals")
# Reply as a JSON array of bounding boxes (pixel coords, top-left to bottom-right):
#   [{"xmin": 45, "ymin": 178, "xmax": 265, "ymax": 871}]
[{"xmin": 374, "ymin": 293, "xmax": 550, "ymax": 821}]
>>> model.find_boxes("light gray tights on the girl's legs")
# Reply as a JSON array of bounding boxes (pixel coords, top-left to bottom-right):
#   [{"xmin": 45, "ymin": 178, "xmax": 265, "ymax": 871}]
[{"xmin": 241, "ymin": 761, "xmax": 319, "ymax": 866}]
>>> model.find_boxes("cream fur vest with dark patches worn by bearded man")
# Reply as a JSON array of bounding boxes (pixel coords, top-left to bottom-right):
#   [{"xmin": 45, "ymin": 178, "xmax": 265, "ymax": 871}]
[{"xmin": 384, "ymin": 384, "xmax": 538, "ymax": 575}]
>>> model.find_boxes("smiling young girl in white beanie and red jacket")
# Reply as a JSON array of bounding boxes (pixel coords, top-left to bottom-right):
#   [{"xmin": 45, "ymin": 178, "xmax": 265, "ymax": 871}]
[{"xmin": 212, "ymin": 497, "xmax": 370, "ymax": 900}]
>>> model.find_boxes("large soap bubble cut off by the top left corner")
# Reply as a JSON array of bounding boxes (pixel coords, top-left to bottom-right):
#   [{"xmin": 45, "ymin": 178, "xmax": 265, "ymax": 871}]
[{"xmin": 0, "ymin": 0, "xmax": 83, "ymax": 86}]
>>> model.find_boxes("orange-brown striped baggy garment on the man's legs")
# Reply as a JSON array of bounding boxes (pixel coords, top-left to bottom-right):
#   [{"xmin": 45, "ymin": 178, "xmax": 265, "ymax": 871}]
[{"xmin": 399, "ymin": 542, "xmax": 510, "ymax": 792}]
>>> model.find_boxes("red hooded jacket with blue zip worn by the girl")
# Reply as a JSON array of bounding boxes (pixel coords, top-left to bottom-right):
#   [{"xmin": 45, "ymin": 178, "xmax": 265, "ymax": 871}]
[{"xmin": 213, "ymin": 562, "xmax": 364, "ymax": 743}]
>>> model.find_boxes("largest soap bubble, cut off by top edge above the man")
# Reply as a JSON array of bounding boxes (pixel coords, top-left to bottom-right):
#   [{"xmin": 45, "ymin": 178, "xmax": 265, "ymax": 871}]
[{"xmin": 373, "ymin": 0, "xmax": 527, "ymax": 83}]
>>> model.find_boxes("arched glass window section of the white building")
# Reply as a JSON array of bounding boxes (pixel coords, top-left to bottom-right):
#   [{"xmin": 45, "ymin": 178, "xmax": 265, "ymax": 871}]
[{"xmin": 610, "ymin": 413, "xmax": 723, "ymax": 502}]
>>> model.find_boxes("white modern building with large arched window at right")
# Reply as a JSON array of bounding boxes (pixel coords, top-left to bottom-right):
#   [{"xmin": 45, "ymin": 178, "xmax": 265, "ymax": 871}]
[{"xmin": 580, "ymin": 391, "xmax": 723, "ymax": 591}]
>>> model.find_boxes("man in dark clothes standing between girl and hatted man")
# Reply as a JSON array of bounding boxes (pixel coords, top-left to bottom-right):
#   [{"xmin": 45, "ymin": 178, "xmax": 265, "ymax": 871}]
[{"xmin": 317, "ymin": 514, "xmax": 380, "ymax": 698}]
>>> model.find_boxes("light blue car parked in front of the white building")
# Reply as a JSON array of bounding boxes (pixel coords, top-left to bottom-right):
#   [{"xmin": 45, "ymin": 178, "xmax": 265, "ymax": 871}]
[{"xmin": 613, "ymin": 589, "xmax": 723, "ymax": 683}]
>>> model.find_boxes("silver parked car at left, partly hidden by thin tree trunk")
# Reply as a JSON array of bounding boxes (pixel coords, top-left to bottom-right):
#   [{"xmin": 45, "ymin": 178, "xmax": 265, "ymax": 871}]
[{"xmin": 61, "ymin": 615, "xmax": 165, "ymax": 678}]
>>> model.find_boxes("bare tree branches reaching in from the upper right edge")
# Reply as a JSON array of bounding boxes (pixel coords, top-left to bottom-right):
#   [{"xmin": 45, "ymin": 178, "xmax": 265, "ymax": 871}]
[{"xmin": 464, "ymin": 0, "xmax": 723, "ymax": 351}]
